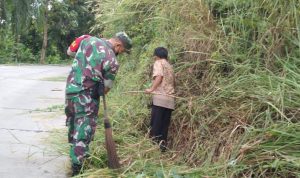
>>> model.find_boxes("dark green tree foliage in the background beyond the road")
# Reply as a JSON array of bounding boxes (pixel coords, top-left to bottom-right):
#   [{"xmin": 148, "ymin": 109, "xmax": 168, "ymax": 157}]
[{"xmin": 0, "ymin": 0, "xmax": 94, "ymax": 63}]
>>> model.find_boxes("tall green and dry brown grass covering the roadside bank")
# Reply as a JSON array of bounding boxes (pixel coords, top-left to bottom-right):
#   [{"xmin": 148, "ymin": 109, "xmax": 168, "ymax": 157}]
[{"xmin": 77, "ymin": 0, "xmax": 300, "ymax": 177}]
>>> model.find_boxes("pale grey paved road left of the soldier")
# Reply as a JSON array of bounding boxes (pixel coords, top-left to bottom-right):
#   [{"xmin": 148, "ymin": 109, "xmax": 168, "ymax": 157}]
[{"xmin": 0, "ymin": 65, "xmax": 70, "ymax": 178}]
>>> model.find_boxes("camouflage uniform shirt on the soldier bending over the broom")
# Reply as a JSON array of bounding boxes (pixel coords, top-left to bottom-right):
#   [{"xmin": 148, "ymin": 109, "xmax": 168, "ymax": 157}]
[{"xmin": 66, "ymin": 37, "xmax": 119, "ymax": 95}]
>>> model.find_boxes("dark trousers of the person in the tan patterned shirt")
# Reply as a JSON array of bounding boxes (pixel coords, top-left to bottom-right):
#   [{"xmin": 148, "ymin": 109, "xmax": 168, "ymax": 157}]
[{"xmin": 150, "ymin": 105, "xmax": 173, "ymax": 151}]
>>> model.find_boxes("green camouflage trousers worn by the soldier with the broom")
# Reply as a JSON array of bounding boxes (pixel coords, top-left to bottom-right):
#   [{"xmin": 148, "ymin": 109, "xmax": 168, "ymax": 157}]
[{"xmin": 65, "ymin": 93, "xmax": 99, "ymax": 164}]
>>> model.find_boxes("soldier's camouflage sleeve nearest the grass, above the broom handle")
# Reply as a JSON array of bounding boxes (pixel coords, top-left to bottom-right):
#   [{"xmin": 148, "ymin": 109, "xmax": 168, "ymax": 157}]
[{"xmin": 103, "ymin": 57, "xmax": 119, "ymax": 88}]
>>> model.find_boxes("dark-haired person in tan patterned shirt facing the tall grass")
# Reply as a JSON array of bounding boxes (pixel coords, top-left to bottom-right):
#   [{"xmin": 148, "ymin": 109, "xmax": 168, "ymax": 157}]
[{"xmin": 145, "ymin": 47, "xmax": 175, "ymax": 152}]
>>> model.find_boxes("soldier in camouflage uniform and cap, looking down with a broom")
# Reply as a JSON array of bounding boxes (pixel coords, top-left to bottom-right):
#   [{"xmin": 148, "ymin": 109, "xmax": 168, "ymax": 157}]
[{"xmin": 65, "ymin": 32, "xmax": 132, "ymax": 175}]
